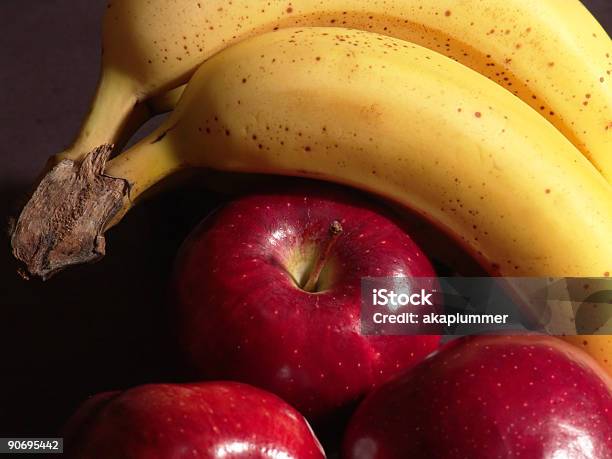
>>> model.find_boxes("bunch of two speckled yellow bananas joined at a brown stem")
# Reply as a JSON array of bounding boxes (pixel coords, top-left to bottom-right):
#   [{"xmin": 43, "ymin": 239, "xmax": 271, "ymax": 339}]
[{"xmin": 12, "ymin": 4, "xmax": 612, "ymax": 371}]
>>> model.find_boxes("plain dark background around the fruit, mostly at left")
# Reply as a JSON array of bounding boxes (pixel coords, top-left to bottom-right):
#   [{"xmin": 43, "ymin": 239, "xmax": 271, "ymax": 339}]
[{"xmin": 0, "ymin": 0, "xmax": 612, "ymax": 436}]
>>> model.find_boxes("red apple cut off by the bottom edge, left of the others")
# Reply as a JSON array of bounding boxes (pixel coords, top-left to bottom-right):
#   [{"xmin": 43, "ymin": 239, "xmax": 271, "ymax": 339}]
[{"xmin": 65, "ymin": 382, "xmax": 325, "ymax": 459}]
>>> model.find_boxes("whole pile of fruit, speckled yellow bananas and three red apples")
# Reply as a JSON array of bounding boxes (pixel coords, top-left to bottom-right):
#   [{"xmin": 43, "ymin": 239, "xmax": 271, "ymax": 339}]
[{"xmin": 11, "ymin": 0, "xmax": 612, "ymax": 459}]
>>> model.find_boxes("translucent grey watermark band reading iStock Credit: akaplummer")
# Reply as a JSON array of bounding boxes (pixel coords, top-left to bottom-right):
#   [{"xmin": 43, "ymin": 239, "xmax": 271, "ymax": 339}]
[{"xmin": 361, "ymin": 277, "xmax": 612, "ymax": 335}]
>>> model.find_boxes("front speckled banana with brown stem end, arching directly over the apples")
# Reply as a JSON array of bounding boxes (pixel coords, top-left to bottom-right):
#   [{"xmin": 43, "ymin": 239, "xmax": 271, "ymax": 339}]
[{"xmin": 12, "ymin": 28, "xmax": 612, "ymax": 371}]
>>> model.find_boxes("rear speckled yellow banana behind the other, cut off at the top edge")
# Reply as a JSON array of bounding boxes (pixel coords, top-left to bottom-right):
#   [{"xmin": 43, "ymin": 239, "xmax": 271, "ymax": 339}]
[{"xmin": 55, "ymin": 0, "xmax": 612, "ymax": 180}]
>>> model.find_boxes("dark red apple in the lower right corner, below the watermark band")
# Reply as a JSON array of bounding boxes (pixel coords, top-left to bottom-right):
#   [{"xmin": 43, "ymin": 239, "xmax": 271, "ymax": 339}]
[{"xmin": 343, "ymin": 336, "xmax": 612, "ymax": 459}]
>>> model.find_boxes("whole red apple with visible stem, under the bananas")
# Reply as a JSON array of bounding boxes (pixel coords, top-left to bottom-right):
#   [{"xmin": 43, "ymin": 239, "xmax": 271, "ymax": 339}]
[{"xmin": 174, "ymin": 185, "xmax": 439, "ymax": 421}]
